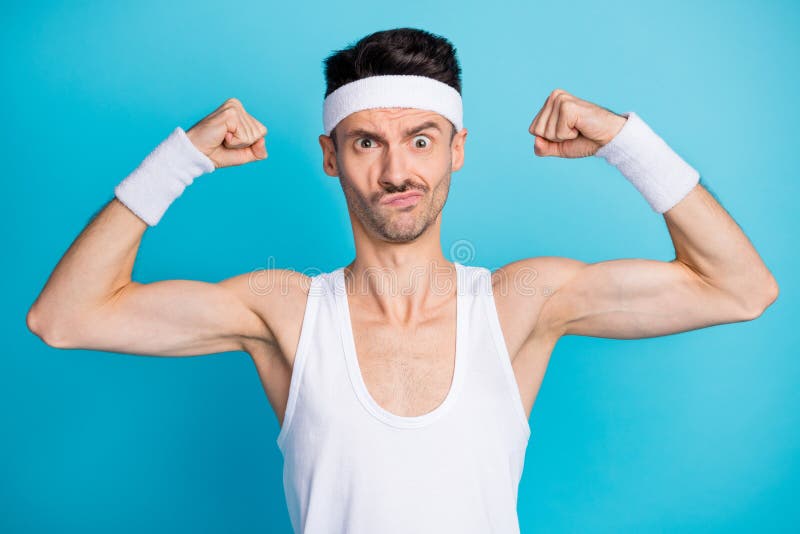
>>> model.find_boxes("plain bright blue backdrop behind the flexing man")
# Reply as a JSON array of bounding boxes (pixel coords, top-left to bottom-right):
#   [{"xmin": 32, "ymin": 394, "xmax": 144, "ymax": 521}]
[{"xmin": 0, "ymin": 1, "xmax": 800, "ymax": 534}]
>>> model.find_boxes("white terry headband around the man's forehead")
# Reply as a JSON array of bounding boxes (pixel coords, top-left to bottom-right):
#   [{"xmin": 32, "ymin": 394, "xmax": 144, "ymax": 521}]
[{"xmin": 322, "ymin": 74, "xmax": 462, "ymax": 135}]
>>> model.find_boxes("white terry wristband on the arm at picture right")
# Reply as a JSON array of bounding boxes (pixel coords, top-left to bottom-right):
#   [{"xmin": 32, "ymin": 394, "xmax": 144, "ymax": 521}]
[{"xmin": 595, "ymin": 111, "xmax": 700, "ymax": 213}]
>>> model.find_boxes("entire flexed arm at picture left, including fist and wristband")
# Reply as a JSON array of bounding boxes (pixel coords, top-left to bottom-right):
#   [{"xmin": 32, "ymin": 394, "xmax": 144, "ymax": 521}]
[{"xmin": 27, "ymin": 99, "xmax": 301, "ymax": 356}]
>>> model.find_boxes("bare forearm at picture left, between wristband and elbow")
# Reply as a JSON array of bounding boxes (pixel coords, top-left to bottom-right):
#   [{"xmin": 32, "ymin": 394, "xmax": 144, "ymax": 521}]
[{"xmin": 28, "ymin": 198, "xmax": 147, "ymax": 344}]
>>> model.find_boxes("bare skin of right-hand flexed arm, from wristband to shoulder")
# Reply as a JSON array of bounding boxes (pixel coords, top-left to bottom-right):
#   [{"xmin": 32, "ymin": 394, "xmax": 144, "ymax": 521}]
[{"xmin": 499, "ymin": 185, "xmax": 778, "ymax": 339}]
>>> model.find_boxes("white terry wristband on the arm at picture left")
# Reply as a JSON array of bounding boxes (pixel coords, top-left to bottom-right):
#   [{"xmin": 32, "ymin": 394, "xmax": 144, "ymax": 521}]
[{"xmin": 114, "ymin": 126, "xmax": 216, "ymax": 226}]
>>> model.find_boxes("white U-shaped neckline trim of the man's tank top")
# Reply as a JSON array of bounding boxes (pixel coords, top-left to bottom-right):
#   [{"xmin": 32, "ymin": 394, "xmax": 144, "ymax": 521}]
[{"xmin": 333, "ymin": 262, "xmax": 467, "ymax": 428}]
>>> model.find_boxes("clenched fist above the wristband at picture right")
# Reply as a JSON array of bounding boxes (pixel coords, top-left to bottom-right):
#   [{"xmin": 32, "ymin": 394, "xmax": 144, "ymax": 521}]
[{"xmin": 528, "ymin": 89, "xmax": 627, "ymax": 158}]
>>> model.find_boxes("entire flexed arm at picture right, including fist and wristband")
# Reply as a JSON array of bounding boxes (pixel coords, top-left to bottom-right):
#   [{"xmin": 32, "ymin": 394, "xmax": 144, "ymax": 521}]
[{"xmin": 496, "ymin": 93, "xmax": 778, "ymax": 346}]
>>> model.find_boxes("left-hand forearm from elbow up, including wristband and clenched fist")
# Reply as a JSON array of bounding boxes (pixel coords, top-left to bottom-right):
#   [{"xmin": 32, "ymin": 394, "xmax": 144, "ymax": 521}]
[{"xmin": 27, "ymin": 98, "xmax": 267, "ymax": 345}]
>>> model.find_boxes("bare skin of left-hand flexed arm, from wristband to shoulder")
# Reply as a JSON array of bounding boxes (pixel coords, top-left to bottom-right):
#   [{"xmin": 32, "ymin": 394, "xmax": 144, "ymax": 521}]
[{"xmin": 28, "ymin": 198, "xmax": 276, "ymax": 356}]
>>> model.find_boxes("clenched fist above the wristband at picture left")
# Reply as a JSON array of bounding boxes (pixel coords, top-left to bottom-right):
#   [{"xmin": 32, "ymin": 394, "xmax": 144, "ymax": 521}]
[{"xmin": 186, "ymin": 98, "xmax": 267, "ymax": 169}]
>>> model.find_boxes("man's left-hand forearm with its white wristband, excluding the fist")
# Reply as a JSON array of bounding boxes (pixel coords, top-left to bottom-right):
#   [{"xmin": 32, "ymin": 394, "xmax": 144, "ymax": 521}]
[{"xmin": 28, "ymin": 120, "xmax": 222, "ymax": 346}]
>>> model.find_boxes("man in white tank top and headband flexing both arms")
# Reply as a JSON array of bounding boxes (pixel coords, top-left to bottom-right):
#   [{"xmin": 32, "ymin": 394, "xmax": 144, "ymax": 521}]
[{"xmin": 28, "ymin": 28, "xmax": 778, "ymax": 533}]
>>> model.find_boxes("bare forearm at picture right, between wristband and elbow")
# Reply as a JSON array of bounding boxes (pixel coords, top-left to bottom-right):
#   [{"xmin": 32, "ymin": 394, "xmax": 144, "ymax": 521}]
[{"xmin": 664, "ymin": 184, "xmax": 778, "ymax": 313}]
